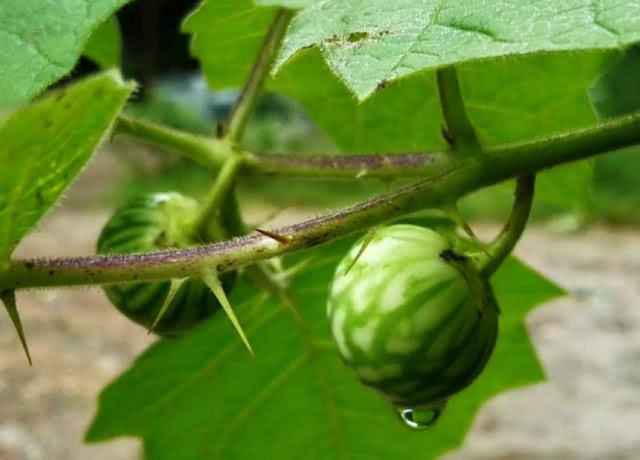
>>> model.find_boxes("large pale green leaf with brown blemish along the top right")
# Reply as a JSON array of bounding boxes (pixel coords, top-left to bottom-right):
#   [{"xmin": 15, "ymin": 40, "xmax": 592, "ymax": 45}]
[{"xmin": 278, "ymin": 0, "xmax": 640, "ymax": 100}]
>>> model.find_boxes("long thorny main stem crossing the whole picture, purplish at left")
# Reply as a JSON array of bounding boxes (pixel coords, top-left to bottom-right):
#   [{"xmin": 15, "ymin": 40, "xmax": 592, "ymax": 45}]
[{"xmin": 0, "ymin": 114, "xmax": 640, "ymax": 292}]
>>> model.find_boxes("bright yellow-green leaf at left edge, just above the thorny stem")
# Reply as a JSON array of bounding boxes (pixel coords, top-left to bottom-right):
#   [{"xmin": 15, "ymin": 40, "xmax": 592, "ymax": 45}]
[{"xmin": 0, "ymin": 71, "xmax": 135, "ymax": 271}]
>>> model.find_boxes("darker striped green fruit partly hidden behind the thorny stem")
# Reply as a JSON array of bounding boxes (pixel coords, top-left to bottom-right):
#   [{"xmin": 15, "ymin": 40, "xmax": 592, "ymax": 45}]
[{"xmin": 97, "ymin": 192, "xmax": 235, "ymax": 336}]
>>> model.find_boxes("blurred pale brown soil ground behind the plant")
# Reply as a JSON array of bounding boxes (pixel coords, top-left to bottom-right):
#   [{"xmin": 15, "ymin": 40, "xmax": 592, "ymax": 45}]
[{"xmin": 0, "ymin": 154, "xmax": 640, "ymax": 460}]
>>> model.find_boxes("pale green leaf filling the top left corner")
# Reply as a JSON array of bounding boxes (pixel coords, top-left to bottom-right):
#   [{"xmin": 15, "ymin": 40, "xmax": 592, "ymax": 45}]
[{"xmin": 0, "ymin": 0, "xmax": 130, "ymax": 109}]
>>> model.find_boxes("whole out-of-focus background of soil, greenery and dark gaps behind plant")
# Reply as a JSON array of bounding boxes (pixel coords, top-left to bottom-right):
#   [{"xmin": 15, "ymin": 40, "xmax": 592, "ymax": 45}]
[{"xmin": 0, "ymin": 0, "xmax": 640, "ymax": 460}]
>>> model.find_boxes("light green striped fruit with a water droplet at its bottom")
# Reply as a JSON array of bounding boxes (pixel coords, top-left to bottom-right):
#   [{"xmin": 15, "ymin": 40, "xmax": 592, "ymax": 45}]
[{"xmin": 327, "ymin": 225, "xmax": 498, "ymax": 416}]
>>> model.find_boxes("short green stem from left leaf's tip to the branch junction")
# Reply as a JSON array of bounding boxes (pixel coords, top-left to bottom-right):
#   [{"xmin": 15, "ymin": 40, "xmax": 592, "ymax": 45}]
[{"xmin": 113, "ymin": 114, "xmax": 233, "ymax": 170}]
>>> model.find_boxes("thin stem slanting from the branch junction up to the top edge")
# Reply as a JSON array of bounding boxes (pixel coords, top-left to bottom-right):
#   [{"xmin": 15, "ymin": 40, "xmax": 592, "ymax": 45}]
[{"xmin": 225, "ymin": 8, "xmax": 293, "ymax": 144}]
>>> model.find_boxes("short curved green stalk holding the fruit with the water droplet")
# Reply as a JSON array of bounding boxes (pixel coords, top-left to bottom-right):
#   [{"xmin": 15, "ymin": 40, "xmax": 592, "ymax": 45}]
[{"xmin": 477, "ymin": 176, "xmax": 535, "ymax": 279}]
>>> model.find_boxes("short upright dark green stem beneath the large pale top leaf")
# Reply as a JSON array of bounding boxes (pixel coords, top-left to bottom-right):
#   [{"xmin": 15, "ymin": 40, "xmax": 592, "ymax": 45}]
[{"xmin": 436, "ymin": 66, "xmax": 480, "ymax": 154}]
